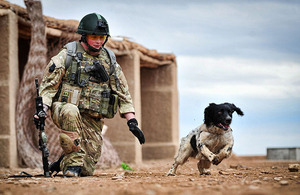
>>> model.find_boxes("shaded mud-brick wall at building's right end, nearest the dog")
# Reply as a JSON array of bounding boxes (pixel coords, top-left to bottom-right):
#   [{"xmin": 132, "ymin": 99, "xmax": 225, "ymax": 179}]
[{"xmin": 141, "ymin": 63, "xmax": 179, "ymax": 160}]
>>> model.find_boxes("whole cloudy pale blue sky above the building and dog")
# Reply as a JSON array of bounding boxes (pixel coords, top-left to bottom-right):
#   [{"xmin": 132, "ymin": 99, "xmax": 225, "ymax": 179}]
[{"xmin": 9, "ymin": 0, "xmax": 300, "ymax": 155}]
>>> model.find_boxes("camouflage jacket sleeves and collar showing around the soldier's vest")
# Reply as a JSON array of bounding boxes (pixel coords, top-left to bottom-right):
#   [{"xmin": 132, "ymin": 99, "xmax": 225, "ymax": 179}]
[{"xmin": 40, "ymin": 41, "xmax": 135, "ymax": 117}]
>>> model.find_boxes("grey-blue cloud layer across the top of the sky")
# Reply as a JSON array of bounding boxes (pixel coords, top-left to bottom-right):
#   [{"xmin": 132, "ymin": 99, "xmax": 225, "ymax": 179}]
[{"xmin": 11, "ymin": 0, "xmax": 300, "ymax": 61}]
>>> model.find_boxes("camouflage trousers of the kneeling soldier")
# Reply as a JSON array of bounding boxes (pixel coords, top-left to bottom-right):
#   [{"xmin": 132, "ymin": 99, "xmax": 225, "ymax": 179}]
[{"xmin": 52, "ymin": 102, "xmax": 103, "ymax": 176}]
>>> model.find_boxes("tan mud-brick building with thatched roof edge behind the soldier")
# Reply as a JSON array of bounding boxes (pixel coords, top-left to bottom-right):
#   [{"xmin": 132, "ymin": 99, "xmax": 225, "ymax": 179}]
[{"xmin": 0, "ymin": 0, "xmax": 179, "ymax": 167}]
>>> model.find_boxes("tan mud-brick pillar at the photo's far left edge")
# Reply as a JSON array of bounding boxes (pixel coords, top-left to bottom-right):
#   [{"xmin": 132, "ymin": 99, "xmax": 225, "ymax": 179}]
[{"xmin": 0, "ymin": 10, "xmax": 19, "ymax": 167}]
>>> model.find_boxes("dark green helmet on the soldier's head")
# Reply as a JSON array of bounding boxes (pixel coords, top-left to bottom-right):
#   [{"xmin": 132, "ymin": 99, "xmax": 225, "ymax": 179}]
[{"xmin": 76, "ymin": 13, "xmax": 110, "ymax": 36}]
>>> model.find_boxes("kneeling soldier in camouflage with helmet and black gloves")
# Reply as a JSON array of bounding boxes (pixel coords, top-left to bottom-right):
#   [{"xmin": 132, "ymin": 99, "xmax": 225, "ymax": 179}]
[{"xmin": 34, "ymin": 13, "xmax": 145, "ymax": 177}]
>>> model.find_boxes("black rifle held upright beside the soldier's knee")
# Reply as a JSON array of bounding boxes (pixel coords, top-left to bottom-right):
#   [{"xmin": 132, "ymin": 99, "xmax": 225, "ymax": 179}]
[{"xmin": 35, "ymin": 78, "xmax": 50, "ymax": 177}]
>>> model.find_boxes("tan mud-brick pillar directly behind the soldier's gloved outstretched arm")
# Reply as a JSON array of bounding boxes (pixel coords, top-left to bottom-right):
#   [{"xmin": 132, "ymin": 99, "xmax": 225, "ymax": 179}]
[{"xmin": 105, "ymin": 50, "xmax": 142, "ymax": 163}]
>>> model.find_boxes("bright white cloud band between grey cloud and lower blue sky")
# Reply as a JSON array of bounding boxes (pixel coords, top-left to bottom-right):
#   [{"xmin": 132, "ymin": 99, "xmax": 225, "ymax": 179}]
[{"xmin": 177, "ymin": 56, "xmax": 300, "ymax": 99}]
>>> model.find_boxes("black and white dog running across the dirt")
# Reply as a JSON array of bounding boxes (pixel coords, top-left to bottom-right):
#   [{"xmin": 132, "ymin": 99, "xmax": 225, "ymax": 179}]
[{"xmin": 167, "ymin": 103, "xmax": 244, "ymax": 176}]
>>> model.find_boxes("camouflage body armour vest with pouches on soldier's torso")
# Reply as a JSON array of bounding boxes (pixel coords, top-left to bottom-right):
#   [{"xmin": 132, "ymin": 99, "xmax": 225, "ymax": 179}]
[{"xmin": 58, "ymin": 43, "xmax": 118, "ymax": 118}]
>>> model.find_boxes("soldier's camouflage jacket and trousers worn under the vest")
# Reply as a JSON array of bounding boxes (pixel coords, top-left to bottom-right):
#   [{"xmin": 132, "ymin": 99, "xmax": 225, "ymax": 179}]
[{"xmin": 40, "ymin": 43, "xmax": 134, "ymax": 175}]
